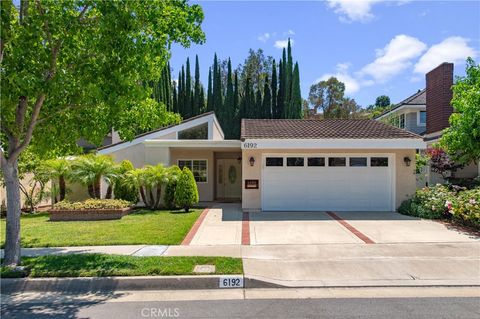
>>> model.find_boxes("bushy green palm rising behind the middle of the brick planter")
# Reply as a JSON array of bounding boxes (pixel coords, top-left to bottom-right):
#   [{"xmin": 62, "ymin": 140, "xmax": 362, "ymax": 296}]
[{"xmin": 71, "ymin": 154, "xmax": 118, "ymax": 198}]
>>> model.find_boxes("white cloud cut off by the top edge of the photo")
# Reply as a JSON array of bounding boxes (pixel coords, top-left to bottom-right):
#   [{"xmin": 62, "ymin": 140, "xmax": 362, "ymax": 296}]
[{"xmin": 327, "ymin": 0, "xmax": 381, "ymax": 22}]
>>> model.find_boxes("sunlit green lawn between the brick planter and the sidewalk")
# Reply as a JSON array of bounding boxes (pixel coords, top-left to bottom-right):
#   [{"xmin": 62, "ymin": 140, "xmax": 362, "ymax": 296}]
[{"xmin": 0, "ymin": 209, "xmax": 202, "ymax": 247}]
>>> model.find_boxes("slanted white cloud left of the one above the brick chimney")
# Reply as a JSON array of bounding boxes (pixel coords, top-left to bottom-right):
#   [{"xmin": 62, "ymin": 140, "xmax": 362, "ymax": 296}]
[{"xmin": 359, "ymin": 34, "xmax": 427, "ymax": 82}]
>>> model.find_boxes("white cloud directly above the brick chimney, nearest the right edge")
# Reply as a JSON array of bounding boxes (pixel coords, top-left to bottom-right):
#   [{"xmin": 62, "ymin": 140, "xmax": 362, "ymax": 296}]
[{"xmin": 414, "ymin": 37, "xmax": 477, "ymax": 74}]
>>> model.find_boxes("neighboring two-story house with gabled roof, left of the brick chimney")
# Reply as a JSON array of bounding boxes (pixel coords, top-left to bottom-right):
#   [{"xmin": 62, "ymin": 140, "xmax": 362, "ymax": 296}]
[{"xmin": 375, "ymin": 89, "xmax": 427, "ymax": 135}]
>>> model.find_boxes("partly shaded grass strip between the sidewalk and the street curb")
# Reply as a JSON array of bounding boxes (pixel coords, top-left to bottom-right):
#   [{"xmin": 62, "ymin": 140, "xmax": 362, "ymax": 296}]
[{"xmin": 1, "ymin": 254, "xmax": 243, "ymax": 278}]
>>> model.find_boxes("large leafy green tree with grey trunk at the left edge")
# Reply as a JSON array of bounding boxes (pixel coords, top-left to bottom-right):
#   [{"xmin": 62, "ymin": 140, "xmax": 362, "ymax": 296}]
[{"xmin": 0, "ymin": 0, "xmax": 204, "ymax": 266}]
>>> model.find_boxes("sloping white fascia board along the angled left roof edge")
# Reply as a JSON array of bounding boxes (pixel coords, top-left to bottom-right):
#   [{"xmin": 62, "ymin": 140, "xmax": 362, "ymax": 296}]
[{"xmin": 98, "ymin": 114, "xmax": 218, "ymax": 154}]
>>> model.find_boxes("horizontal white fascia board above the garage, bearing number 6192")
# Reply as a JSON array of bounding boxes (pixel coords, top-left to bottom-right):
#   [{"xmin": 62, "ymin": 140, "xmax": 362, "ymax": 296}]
[{"xmin": 242, "ymin": 138, "xmax": 426, "ymax": 149}]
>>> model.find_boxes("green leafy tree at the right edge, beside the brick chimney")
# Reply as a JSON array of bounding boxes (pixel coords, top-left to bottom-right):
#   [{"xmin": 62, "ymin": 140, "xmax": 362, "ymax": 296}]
[{"xmin": 440, "ymin": 58, "xmax": 480, "ymax": 164}]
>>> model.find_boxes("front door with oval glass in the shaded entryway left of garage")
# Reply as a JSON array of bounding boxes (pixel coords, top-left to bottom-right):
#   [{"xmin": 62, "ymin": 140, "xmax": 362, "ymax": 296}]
[{"xmin": 217, "ymin": 159, "xmax": 242, "ymax": 199}]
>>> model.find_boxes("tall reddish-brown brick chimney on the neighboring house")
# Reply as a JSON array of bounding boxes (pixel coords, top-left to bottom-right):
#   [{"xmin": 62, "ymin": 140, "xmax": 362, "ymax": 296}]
[{"xmin": 425, "ymin": 62, "xmax": 453, "ymax": 134}]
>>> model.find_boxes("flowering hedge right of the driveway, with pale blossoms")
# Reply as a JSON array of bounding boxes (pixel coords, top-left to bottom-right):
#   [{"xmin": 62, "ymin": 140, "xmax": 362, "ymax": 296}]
[{"xmin": 398, "ymin": 184, "xmax": 480, "ymax": 228}]
